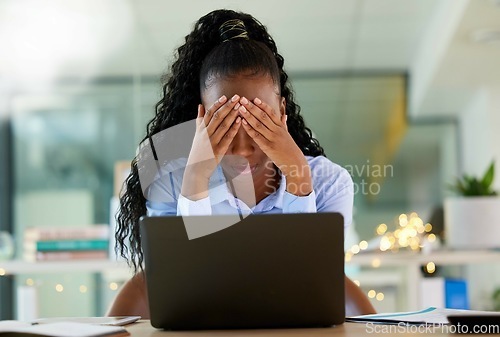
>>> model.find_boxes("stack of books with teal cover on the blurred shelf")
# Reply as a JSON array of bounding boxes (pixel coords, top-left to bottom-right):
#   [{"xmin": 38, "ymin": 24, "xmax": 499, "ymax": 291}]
[{"xmin": 23, "ymin": 225, "xmax": 110, "ymax": 261}]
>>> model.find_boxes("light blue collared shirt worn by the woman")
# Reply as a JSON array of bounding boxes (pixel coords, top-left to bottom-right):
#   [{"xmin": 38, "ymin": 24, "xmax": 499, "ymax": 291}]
[{"xmin": 146, "ymin": 156, "xmax": 354, "ymax": 229}]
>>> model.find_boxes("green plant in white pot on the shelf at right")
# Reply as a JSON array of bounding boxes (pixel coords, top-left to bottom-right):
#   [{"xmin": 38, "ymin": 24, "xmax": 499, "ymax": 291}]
[{"xmin": 444, "ymin": 161, "xmax": 500, "ymax": 249}]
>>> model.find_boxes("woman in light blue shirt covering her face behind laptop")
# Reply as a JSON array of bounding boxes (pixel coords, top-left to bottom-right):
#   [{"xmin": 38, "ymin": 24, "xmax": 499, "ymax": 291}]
[{"xmin": 108, "ymin": 10, "xmax": 374, "ymax": 317}]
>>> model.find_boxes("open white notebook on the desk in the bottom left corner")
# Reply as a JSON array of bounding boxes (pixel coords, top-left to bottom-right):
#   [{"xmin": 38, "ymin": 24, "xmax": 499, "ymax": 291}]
[{"xmin": 0, "ymin": 321, "xmax": 129, "ymax": 337}]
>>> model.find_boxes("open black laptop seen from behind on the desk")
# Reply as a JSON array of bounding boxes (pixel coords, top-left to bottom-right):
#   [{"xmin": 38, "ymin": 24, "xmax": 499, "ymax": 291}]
[{"xmin": 140, "ymin": 213, "xmax": 345, "ymax": 330}]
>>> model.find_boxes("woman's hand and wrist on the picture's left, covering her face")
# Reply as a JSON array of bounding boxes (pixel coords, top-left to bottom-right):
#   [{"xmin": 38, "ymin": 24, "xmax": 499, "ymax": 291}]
[{"xmin": 181, "ymin": 95, "xmax": 241, "ymax": 200}]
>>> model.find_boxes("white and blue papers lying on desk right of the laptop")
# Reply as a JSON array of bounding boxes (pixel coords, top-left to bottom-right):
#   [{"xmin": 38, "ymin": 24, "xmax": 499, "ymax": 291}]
[{"xmin": 346, "ymin": 307, "xmax": 491, "ymax": 325}]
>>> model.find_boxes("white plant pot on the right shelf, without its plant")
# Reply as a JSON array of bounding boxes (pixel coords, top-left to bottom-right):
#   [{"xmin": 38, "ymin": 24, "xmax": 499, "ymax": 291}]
[{"xmin": 444, "ymin": 197, "xmax": 500, "ymax": 249}]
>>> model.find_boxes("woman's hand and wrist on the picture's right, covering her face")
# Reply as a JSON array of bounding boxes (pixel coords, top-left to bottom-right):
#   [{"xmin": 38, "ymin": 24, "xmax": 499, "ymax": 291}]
[{"xmin": 238, "ymin": 97, "xmax": 313, "ymax": 196}]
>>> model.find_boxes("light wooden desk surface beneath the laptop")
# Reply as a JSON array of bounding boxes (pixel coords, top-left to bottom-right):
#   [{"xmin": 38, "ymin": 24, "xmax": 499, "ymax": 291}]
[{"xmin": 126, "ymin": 320, "xmax": 500, "ymax": 337}]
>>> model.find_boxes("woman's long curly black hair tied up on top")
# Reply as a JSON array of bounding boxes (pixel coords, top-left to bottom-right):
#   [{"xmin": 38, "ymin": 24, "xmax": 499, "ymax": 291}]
[{"xmin": 115, "ymin": 10, "xmax": 325, "ymax": 272}]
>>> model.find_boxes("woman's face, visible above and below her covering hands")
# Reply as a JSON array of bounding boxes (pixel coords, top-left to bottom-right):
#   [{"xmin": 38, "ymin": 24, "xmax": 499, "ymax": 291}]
[{"xmin": 201, "ymin": 74, "xmax": 285, "ymax": 183}]
